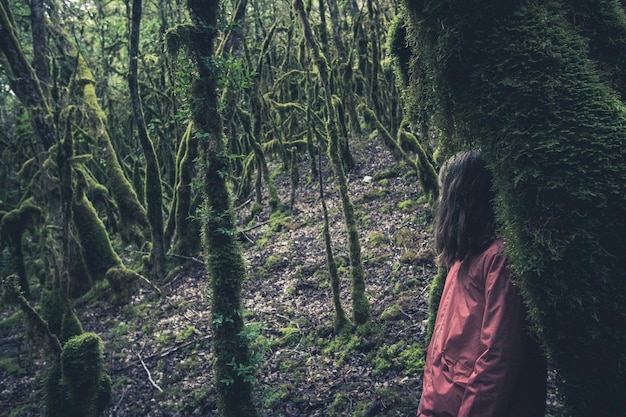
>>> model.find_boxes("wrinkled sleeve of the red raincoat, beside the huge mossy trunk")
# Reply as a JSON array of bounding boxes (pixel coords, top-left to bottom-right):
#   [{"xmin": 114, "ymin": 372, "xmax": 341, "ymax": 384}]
[{"xmin": 457, "ymin": 250, "xmax": 525, "ymax": 417}]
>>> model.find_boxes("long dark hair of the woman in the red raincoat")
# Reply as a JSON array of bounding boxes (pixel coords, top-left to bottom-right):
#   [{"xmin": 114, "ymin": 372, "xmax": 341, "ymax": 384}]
[{"xmin": 435, "ymin": 150, "xmax": 496, "ymax": 266}]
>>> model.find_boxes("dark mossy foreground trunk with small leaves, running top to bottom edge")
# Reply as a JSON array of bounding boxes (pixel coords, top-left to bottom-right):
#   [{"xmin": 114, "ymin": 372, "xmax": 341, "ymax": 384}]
[{"xmin": 187, "ymin": 0, "xmax": 257, "ymax": 417}]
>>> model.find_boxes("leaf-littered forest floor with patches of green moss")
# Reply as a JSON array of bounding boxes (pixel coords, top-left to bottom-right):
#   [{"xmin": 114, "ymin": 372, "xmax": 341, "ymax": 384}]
[{"xmin": 0, "ymin": 135, "xmax": 561, "ymax": 417}]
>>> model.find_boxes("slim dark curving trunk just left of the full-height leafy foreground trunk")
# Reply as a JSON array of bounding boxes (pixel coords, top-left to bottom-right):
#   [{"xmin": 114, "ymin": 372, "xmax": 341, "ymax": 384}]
[{"xmin": 128, "ymin": 0, "xmax": 165, "ymax": 279}]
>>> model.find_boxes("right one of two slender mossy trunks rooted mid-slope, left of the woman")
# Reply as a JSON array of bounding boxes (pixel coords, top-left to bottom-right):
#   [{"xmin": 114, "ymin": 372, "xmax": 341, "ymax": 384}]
[{"xmin": 294, "ymin": 0, "xmax": 371, "ymax": 326}]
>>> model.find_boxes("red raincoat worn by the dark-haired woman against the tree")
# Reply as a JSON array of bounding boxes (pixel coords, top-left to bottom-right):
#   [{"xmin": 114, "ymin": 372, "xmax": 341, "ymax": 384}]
[{"xmin": 417, "ymin": 241, "xmax": 546, "ymax": 417}]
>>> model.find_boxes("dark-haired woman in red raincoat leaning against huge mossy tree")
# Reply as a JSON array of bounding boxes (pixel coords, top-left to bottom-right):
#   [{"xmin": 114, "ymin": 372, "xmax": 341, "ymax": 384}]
[{"xmin": 417, "ymin": 151, "xmax": 546, "ymax": 417}]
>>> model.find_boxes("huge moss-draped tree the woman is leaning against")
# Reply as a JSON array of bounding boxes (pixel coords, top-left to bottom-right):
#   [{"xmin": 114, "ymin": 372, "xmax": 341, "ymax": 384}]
[{"xmin": 404, "ymin": 0, "xmax": 626, "ymax": 416}]
